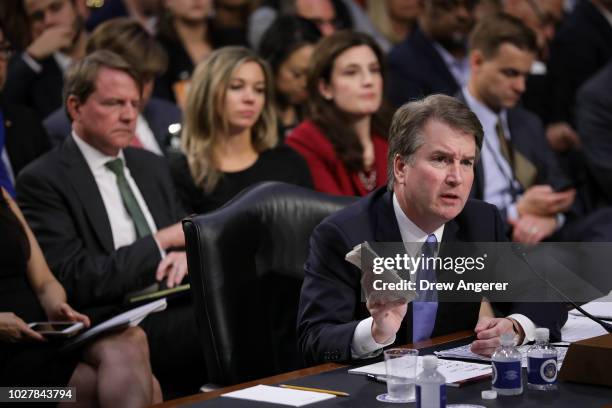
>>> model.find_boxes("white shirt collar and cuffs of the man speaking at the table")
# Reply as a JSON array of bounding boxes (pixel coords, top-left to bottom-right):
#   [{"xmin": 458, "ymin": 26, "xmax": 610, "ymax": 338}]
[{"xmin": 351, "ymin": 194, "xmax": 536, "ymax": 359}]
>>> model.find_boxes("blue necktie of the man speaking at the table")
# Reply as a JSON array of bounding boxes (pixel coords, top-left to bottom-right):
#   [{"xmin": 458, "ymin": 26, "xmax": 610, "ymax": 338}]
[{"xmin": 412, "ymin": 234, "xmax": 438, "ymax": 342}]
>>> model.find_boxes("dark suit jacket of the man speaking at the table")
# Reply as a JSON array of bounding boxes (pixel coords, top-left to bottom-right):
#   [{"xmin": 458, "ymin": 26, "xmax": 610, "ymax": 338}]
[{"xmin": 298, "ymin": 188, "xmax": 567, "ymax": 364}]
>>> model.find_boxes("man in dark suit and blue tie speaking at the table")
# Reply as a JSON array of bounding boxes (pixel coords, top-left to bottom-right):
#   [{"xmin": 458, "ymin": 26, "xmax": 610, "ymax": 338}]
[{"xmin": 298, "ymin": 95, "xmax": 567, "ymax": 363}]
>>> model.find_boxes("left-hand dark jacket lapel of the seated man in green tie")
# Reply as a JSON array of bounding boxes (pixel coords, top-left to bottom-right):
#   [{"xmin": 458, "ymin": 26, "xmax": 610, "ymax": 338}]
[{"xmin": 62, "ymin": 136, "xmax": 115, "ymax": 253}]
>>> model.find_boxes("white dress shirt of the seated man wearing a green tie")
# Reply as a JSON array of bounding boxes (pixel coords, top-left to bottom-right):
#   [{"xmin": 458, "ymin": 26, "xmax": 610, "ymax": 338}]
[{"xmin": 72, "ymin": 132, "xmax": 163, "ymax": 250}]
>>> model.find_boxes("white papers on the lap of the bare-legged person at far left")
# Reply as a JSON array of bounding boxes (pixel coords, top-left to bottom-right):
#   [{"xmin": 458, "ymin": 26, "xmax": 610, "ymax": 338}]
[{"xmin": 61, "ymin": 298, "xmax": 167, "ymax": 351}]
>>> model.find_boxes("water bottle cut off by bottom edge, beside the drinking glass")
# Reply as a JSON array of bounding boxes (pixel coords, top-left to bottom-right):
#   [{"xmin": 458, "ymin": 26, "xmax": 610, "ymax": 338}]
[{"xmin": 416, "ymin": 356, "xmax": 446, "ymax": 408}]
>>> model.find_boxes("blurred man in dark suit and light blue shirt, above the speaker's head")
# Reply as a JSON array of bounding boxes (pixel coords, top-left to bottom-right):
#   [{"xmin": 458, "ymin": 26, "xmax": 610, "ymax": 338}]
[{"xmin": 387, "ymin": 0, "xmax": 474, "ymax": 106}]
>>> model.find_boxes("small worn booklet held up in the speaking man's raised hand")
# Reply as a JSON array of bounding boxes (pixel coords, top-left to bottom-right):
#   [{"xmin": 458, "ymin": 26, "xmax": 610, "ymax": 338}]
[{"xmin": 344, "ymin": 242, "xmax": 417, "ymax": 303}]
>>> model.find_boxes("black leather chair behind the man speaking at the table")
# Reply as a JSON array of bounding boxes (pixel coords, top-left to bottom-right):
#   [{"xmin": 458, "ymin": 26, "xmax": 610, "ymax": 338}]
[{"xmin": 183, "ymin": 182, "xmax": 355, "ymax": 385}]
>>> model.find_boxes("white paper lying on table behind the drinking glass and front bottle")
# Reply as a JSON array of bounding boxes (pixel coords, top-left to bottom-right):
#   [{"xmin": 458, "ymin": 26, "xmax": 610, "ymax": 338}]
[{"xmin": 348, "ymin": 356, "xmax": 492, "ymax": 384}]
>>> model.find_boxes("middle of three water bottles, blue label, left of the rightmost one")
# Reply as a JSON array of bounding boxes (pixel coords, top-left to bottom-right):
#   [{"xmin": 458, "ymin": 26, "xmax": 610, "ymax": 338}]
[{"xmin": 491, "ymin": 333, "xmax": 523, "ymax": 395}]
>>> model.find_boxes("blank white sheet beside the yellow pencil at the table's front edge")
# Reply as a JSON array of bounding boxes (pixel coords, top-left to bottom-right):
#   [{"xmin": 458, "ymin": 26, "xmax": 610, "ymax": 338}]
[{"xmin": 221, "ymin": 384, "xmax": 336, "ymax": 407}]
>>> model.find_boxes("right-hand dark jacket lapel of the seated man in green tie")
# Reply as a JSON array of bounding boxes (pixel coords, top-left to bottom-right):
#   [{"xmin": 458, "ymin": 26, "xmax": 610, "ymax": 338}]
[{"xmin": 123, "ymin": 147, "xmax": 168, "ymax": 228}]
